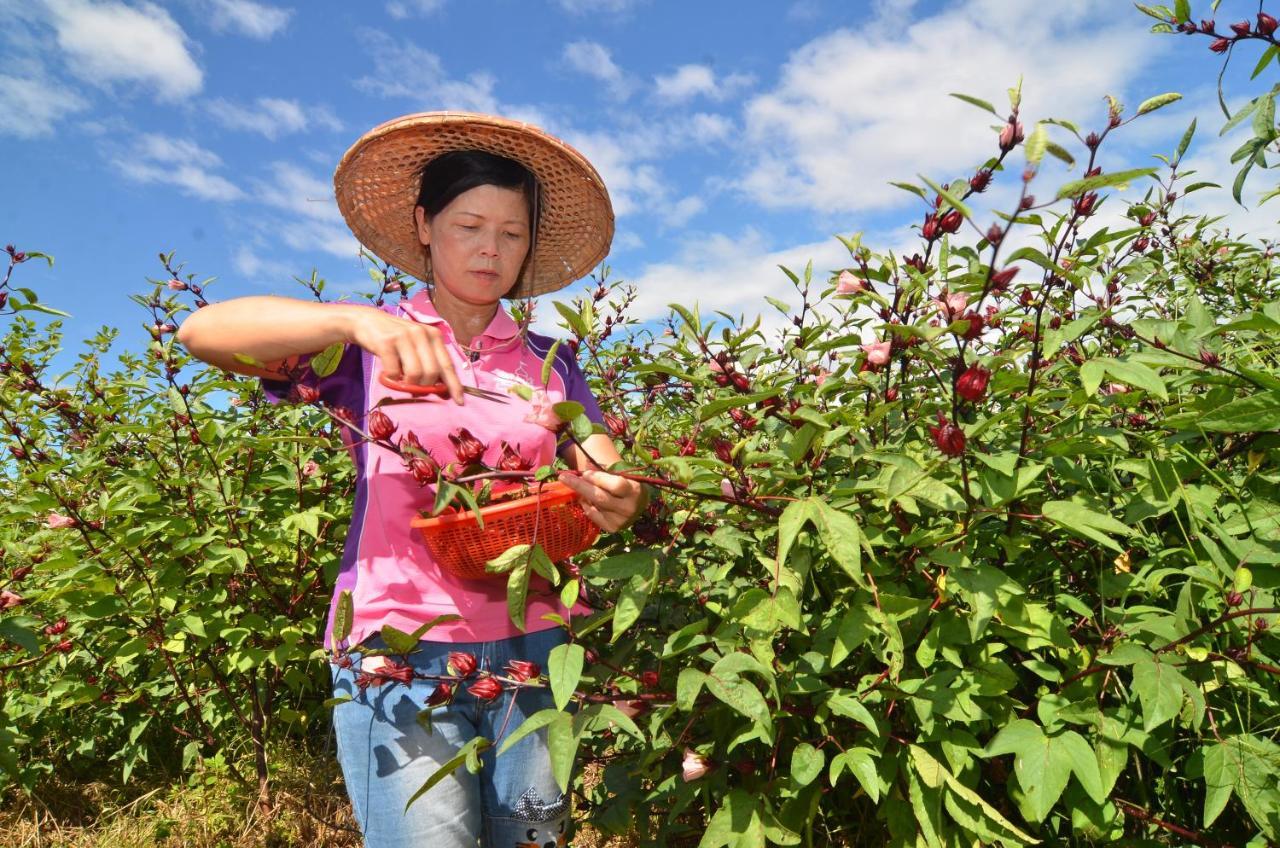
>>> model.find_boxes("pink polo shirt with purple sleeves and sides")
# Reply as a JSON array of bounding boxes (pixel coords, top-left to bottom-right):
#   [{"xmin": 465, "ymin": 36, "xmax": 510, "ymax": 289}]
[{"xmin": 262, "ymin": 292, "xmax": 603, "ymax": 647}]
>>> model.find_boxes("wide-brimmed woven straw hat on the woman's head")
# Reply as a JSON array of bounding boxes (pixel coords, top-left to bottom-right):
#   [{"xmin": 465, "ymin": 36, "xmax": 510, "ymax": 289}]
[{"xmin": 333, "ymin": 111, "xmax": 613, "ymax": 297}]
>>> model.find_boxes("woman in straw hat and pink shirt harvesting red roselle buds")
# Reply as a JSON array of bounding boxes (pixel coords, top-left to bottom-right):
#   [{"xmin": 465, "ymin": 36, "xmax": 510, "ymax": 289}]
[{"xmin": 178, "ymin": 113, "xmax": 645, "ymax": 848}]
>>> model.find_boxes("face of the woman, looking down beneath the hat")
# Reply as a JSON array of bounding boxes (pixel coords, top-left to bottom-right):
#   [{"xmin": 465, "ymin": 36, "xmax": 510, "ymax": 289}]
[{"xmin": 413, "ymin": 186, "xmax": 530, "ymax": 306}]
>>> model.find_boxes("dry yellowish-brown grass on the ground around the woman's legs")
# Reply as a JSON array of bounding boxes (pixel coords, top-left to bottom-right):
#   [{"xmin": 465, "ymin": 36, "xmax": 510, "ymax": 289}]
[{"xmin": 0, "ymin": 749, "xmax": 639, "ymax": 848}]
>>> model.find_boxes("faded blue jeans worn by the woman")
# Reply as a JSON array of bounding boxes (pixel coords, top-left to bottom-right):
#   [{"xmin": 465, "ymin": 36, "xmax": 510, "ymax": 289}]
[{"xmin": 333, "ymin": 628, "xmax": 570, "ymax": 848}]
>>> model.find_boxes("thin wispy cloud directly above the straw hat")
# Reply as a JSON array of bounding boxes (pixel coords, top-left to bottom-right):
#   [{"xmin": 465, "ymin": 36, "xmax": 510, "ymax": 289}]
[{"xmin": 355, "ymin": 29, "xmax": 499, "ymax": 113}]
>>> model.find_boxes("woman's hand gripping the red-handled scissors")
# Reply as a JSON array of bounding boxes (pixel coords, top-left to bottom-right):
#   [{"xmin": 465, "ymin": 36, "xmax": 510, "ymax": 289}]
[{"xmin": 348, "ymin": 309, "xmax": 462, "ymax": 404}]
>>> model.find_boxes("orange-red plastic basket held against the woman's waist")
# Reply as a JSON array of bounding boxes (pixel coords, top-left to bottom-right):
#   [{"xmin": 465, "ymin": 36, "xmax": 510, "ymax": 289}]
[{"xmin": 410, "ymin": 480, "xmax": 600, "ymax": 579}]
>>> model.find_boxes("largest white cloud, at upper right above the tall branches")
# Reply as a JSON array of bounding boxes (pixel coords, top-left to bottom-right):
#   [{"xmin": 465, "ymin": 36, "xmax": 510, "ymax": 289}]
[{"xmin": 740, "ymin": 0, "xmax": 1162, "ymax": 213}]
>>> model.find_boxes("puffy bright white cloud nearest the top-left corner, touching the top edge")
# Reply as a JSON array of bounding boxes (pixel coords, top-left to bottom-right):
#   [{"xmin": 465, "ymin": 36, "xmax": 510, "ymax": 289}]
[{"xmin": 44, "ymin": 0, "xmax": 204, "ymax": 101}]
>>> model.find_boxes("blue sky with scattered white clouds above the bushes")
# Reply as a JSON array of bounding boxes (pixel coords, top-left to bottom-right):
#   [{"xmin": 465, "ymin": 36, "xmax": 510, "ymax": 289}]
[{"xmin": 0, "ymin": 0, "xmax": 1276, "ymax": 358}]
